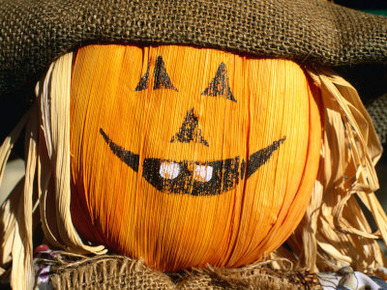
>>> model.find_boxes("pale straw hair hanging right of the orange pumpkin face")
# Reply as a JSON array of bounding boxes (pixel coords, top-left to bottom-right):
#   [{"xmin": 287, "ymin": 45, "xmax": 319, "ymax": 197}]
[{"xmin": 288, "ymin": 71, "xmax": 387, "ymax": 272}]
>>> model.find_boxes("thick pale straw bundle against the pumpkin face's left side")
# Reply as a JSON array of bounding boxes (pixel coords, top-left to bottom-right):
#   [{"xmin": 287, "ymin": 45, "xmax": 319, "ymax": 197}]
[{"xmin": 40, "ymin": 53, "xmax": 104, "ymax": 253}]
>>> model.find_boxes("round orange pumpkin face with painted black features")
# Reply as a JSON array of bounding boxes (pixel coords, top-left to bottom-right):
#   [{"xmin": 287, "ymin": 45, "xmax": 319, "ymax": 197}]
[{"xmin": 71, "ymin": 45, "xmax": 321, "ymax": 271}]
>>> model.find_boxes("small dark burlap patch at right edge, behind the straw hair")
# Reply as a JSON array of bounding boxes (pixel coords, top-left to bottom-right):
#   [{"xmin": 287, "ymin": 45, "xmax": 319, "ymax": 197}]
[{"xmin": 367, "ymin": 93, "xmax": 387, "ymax": 144}]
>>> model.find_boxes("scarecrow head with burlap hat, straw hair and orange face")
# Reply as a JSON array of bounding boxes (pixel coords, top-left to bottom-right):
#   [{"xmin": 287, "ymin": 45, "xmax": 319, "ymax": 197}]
[{"xmin": 0, "ymin": 0, "xmax": 387, "ymax": 287}]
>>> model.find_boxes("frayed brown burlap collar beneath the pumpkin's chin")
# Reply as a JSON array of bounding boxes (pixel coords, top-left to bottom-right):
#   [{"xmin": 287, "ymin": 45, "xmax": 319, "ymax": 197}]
[{"xmin": 51, "ymin": 256, "xmax": 322, "ymax": 289}]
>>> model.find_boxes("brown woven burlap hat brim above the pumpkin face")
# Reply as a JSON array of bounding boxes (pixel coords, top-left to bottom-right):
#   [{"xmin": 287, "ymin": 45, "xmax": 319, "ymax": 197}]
[{"xmin": 0, "ymin": 0, "xmax": 387, "ymax": 94}]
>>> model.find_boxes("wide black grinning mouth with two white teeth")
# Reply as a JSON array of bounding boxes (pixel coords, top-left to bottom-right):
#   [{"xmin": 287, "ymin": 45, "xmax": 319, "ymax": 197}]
[{"xmin": 99, "ymin": 129, "xmax": 286, "ymax": 196}]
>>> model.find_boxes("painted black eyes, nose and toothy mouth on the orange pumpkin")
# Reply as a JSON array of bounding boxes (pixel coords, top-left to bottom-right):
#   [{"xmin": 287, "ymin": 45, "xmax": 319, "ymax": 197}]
[{"xmin": 100, "ymin": 56, "xmax": 286, "ymax": 196}]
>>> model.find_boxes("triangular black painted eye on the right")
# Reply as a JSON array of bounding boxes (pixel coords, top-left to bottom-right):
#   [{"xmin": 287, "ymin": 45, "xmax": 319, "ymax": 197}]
[{"xmin": 202, "ymin": 62, "xmax": 236, "ymax": 102}]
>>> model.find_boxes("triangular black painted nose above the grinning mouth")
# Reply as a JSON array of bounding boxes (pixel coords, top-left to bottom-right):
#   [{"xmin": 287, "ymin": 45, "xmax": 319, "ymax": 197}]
[{"xmin": 171, "ymin": 108, "xmax": 209, "ymax": 146}]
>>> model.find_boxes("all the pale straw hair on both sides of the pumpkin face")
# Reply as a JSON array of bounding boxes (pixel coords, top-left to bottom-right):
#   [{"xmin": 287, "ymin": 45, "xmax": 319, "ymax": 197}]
[{"xmin": 0, "ymin": 54, "xmax": 387, "ymax": 289}]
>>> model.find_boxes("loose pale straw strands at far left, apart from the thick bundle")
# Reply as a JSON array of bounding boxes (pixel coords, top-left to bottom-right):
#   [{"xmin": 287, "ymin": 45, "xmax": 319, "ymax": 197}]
[{"xmin": 0, "ymin": 106, "xmax": 36, "ymax": 289}]
